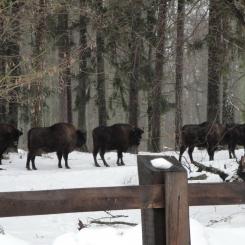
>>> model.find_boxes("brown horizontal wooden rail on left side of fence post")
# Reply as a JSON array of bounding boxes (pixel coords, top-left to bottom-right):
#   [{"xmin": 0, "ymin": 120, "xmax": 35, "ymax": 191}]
[{"xmin": 0, "ymin": 185, "xmax": 164, "ymax": 217}]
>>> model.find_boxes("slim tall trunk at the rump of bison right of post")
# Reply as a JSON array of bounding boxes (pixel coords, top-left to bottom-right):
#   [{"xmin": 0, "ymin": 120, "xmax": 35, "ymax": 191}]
[{"xmin": 175, "ymin": 0, "xmax": 185, "ymax": 150}]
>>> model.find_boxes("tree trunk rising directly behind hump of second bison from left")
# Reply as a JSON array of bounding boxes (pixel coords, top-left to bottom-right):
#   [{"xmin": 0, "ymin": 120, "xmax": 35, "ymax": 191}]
[{"xmin": 57, "ymin": 6, "xmax": 72, "ymax": 123}]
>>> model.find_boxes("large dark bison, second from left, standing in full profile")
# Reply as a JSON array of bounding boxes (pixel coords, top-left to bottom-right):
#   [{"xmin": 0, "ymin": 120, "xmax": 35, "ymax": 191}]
[{"xmin": 26, "ymin": 123, "xmax": 86, "ymax": 170}]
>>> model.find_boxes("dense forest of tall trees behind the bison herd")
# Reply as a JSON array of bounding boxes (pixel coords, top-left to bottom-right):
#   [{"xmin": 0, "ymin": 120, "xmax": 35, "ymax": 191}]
[{"xmin": 0, "ymin": 0, "xmax": 245, "ymax": 152}]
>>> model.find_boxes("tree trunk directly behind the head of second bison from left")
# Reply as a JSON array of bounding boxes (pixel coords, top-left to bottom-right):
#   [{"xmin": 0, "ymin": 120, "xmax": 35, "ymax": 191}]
[{"xmin": 76, "ymin": 0, "xmax": 89, "ymax": 131}]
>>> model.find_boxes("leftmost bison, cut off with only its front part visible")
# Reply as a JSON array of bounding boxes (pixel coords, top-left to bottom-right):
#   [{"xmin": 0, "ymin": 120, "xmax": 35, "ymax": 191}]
[{"xmin": 0, "ymin": 123, "xmax": 23, "ymax": 164}]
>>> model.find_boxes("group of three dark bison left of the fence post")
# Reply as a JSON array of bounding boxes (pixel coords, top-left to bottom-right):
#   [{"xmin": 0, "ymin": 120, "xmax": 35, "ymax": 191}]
[{"xmin": 0, "ymin": 123, "xmax": 144, "ymax": 170}]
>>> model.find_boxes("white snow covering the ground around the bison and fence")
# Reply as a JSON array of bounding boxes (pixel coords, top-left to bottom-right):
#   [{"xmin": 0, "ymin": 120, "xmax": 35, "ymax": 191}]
[{"xmin": 0, "ymin": 150, "xmax": 245, "ymax": 245}]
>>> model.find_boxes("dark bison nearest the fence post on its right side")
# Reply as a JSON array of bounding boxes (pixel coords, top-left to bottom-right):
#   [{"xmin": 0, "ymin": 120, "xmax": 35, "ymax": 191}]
[{"xmin": 179, "ymin": 122, "xmax": 227, "ymax": 162}]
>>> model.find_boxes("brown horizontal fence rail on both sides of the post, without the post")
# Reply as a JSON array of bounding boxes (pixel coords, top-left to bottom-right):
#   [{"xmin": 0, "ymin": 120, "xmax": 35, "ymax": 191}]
[{"xmin": 0, "ymin": 183, "xmax": 245, "ymax": 217}]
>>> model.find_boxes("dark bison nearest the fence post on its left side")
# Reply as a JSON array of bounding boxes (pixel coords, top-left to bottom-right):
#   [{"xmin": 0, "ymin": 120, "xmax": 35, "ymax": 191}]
[{"xmin": 93, "ymin": 124, "xmax": 144, "ymax": 167}]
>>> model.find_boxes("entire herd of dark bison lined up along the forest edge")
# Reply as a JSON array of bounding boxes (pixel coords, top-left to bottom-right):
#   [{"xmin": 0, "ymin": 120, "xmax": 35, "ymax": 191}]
[{"xmin": 0, "ymin": 122, "xmax": 245, "ymax": 170}]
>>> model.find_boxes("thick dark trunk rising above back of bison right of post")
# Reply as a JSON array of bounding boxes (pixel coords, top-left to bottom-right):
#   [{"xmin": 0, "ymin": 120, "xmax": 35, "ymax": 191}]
[{"xmin": 207, "ymin": 0, "xmax": 224, "ymax": 122}]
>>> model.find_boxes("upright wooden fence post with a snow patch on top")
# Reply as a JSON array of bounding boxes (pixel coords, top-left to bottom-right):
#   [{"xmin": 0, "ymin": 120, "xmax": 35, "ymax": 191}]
[{"xmin": 137, "ymin": 155, "xmax": 190, "ymax": 245}]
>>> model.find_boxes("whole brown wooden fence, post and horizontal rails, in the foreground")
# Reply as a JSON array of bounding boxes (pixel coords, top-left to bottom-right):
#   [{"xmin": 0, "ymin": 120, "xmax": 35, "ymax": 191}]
[{"xmin": 0, "ymin": 155, "xmax": 245, "ymax": 245}]
